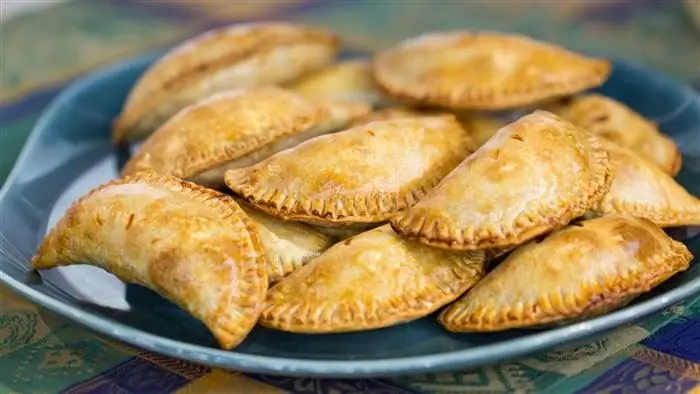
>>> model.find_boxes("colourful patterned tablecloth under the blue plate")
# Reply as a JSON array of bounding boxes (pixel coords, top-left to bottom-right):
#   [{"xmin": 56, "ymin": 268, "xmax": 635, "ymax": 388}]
[{"xmin": 0, "ymin": 0, "xmax": 700, "ymax": 394}]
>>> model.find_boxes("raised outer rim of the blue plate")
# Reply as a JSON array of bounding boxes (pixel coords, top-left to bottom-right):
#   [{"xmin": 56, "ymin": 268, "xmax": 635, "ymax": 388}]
[{"xmin": 0, "ymin": 51, "xmax": 700, "ymax": 378}]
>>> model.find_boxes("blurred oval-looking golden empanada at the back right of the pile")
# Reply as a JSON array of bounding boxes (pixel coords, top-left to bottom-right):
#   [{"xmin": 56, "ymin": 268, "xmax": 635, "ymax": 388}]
[{"xmin": 373, "ymin": 30, "xmax": 611, "ymax": 110}]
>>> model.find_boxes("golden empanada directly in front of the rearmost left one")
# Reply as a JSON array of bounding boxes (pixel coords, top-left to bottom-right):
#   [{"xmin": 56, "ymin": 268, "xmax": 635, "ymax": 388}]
[{"xmin": 122, "ymin": 86, "xmax": 370, "ymax": 188}]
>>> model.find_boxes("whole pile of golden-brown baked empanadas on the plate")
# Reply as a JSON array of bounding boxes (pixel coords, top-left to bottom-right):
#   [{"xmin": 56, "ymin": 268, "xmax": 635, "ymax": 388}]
[{"xmin": 32, "ymin": 23, "xmax": 700, "ymax": 348}]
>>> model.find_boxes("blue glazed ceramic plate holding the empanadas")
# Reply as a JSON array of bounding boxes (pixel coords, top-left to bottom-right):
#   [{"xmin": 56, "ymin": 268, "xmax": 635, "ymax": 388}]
[{"xmin": 0, "ymin": 55, "xmax": 700, "ymax": 376}]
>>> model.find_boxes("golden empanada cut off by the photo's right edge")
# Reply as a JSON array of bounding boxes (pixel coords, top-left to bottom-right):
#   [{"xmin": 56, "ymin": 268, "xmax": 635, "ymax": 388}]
[{"xmin": 593, "ymin": 140, "xmax": 700, "ymax": 227}]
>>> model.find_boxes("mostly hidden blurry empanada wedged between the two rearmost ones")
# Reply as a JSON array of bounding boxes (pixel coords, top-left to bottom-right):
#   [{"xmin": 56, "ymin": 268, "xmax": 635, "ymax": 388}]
[{"xmin": 287, "ymin": 59, "xmax": 388, "ymax": 107}]
